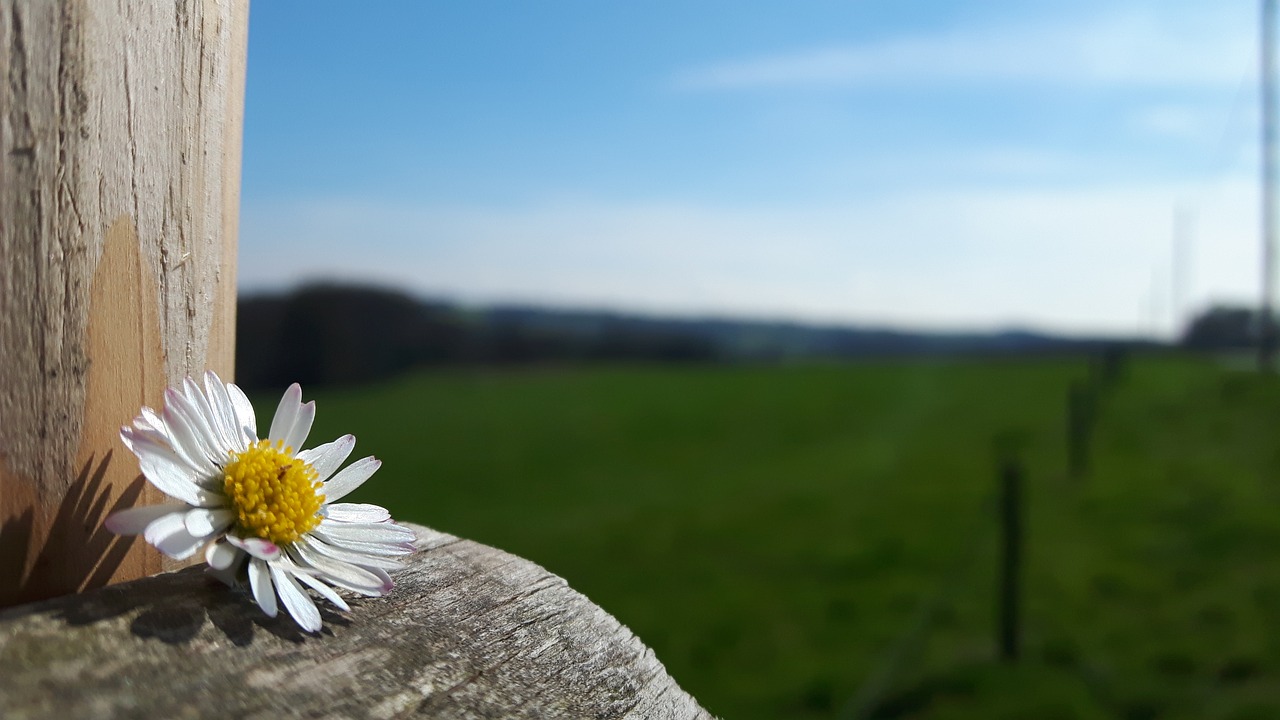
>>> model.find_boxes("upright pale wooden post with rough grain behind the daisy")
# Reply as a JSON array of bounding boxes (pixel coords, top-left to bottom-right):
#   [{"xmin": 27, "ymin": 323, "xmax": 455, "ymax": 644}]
[{"xmin": 0, "ymin": 0, "xmax": 248, "ymax": 606}]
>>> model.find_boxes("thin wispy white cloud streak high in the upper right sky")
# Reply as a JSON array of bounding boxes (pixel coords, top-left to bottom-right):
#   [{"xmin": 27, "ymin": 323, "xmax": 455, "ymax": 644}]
[{"xmin": 673, "ymin": 3, "xmax": 1257, "ymax": 90}]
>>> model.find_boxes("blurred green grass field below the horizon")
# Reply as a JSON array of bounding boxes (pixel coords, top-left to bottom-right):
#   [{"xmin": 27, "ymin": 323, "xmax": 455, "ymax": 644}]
[{"xmin": 262, "ymin": 359, "xmax": 1280, "ymax": 720}]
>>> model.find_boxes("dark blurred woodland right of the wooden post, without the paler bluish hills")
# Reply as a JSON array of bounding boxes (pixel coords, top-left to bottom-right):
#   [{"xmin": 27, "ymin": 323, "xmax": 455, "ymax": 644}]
[{"xmin": 236, "ymin": 284, "xmax": 717, "ymax": 388}]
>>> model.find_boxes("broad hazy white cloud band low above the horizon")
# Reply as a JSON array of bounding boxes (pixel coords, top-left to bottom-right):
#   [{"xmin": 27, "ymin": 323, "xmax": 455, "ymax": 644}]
[{"xmin": 239, "ymin": 179, "xmax": 1257, "ymax": 333}]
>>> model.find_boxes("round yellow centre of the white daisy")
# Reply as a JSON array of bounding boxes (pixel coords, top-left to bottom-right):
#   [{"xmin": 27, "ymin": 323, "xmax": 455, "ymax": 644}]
[{"xmin": 223, "ymin": 439, "xmax": 324, "ymax": 544}]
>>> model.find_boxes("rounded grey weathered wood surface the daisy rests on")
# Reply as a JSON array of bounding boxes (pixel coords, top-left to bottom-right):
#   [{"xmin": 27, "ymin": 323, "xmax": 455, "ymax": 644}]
[{"xmin": 0, "ymin": 527, "xmax": 710, "ymax": 720}]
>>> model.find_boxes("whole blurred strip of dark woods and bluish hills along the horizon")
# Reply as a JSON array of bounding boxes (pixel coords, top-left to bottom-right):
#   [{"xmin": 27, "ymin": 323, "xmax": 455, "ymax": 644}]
[{"xmin": 236, "ymin": 284, "xmax": 1167, "ymax": 388}]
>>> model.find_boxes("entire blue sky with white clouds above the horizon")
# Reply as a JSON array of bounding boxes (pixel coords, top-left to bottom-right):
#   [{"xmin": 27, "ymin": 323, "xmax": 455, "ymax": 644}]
[{"xmin": 239, "ymin": 0, "xmax": 1260, "ymax": 334}]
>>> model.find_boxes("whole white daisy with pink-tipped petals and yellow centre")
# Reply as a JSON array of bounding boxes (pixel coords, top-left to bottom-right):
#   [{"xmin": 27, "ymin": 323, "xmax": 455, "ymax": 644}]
[{"xmin": 106, "ymin": 372, "xmax": 413, "ymax": 633}]
